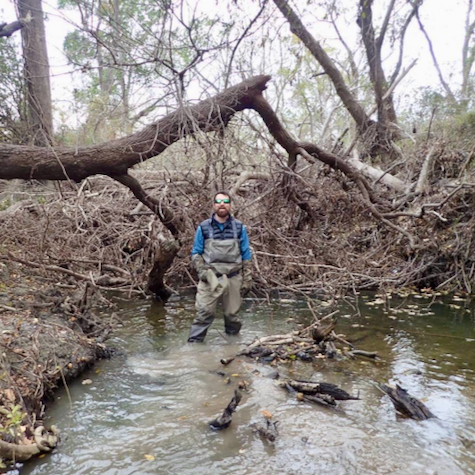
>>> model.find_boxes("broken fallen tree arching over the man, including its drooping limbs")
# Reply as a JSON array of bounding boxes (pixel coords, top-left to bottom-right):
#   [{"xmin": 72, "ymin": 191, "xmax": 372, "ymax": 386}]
[{"xmin": 0, "ymin": 76, "xmax": 399, "ymax": 295}]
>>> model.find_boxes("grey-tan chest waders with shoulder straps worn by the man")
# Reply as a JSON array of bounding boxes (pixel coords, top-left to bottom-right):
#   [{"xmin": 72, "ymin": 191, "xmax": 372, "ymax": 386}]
[{"xmin": 188, "ymin": 220, "xmax": 242, "ymax": 342}]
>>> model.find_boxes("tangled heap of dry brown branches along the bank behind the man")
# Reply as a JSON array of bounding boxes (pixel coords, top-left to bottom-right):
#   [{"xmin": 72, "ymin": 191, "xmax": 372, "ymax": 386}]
[{"xmin": 0, "ymin": 136, "xmax": 475, "ymax": 296}]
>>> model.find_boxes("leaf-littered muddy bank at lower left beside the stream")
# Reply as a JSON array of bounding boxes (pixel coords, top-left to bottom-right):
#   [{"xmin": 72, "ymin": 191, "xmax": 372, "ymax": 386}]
[{"xmin": 0, "ymin": 262, "xmax": 114, "ymax": 466}]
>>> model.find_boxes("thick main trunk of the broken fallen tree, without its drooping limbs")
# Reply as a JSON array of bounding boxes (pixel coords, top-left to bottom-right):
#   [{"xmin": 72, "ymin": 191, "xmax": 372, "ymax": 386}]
[{"xmin": 0, "ymin": 76, "xmax": 270, "ymax": 182}]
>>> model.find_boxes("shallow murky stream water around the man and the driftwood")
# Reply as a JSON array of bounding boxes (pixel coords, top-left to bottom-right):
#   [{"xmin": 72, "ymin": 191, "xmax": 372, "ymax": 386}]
[{"xmin": 16, "ymin": 296, "xmax": 475, "ymax": 475}]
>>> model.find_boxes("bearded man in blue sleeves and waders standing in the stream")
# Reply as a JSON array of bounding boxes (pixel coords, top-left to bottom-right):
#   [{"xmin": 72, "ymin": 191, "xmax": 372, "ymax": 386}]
[{"xmin": 188, "ymin": 191, "xmax": 252, "ymax": 342}]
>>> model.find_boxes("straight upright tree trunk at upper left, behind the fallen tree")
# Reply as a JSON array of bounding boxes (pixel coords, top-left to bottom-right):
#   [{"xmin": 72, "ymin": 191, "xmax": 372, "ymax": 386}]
[{"xmin": 16, "ymin": 0, "xmax": 53, "ymax": 147}]
